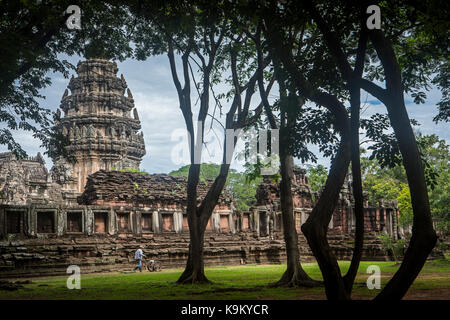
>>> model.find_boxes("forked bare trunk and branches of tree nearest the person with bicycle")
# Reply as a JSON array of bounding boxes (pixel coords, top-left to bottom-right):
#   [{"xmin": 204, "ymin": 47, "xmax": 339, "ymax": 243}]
[{"xmin": 167, "ymin": 29, "xmax": 260, "ymax": 283}]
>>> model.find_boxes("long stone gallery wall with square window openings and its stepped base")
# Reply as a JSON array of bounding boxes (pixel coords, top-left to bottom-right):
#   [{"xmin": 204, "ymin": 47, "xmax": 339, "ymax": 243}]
[{"xmin": 0, "ymin": 199, "xmax": 398, "ymax": 277}]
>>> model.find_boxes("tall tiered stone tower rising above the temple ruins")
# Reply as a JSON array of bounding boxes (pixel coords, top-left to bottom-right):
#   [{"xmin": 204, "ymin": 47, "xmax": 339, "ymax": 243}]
[{"xmin": 51, "ymin": 59, "xmax": 145, "ymax": 192}]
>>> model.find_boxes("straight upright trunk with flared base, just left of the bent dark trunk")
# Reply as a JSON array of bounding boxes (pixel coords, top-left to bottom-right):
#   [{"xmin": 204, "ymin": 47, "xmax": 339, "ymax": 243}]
[{"xmin": 276, "ymin": 152, "xmax": 320, "ymax": 287}]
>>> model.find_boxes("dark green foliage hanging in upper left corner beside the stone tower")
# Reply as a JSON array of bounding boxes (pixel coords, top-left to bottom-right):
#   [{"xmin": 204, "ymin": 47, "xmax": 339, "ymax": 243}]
[{"xmin": 0, "ymin": 0, "xmax": 132, "ymax": 161}]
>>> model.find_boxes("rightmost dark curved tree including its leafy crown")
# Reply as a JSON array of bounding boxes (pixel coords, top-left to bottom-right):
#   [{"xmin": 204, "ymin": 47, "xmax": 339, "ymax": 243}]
[{"xmin": 307, "ymin": 1, "xmax": 448, "ymax": 299}]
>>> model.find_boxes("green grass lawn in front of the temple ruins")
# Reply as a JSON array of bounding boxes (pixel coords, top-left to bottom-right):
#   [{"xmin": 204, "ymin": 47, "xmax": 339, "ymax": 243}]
[{"xmin": 0, "ymin": 258, "xmax": 450, "ymax": 300}]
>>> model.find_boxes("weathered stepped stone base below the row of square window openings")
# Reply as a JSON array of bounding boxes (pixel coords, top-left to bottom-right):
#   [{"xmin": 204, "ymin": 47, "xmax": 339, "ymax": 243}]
[{"xmin": 0, "ymin": 228, "xmax": 388, "ymax": 278}]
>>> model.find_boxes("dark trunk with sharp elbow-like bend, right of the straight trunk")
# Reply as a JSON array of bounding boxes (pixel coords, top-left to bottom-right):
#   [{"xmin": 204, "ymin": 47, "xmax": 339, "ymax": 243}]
[{"xmin": 266, "ymin": 20, "xmax": 351, "ymax": 300}]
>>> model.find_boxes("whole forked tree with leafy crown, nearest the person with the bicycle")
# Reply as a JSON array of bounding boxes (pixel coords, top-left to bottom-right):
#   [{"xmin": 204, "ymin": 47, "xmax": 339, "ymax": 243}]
[{"xmin": 131, "ymin": 1, "xmax": 270, "ymax": 283}]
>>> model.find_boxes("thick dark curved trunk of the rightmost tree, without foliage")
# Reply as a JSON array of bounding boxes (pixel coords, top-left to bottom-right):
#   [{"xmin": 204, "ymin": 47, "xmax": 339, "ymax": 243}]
[{"xmin": 364, "ymin": 30, "xmax": 437, "ymax": 300}]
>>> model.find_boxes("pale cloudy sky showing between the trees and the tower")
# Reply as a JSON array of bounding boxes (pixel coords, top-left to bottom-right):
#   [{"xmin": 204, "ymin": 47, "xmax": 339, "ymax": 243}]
[{"xmin": 0, "ymin": 52, "xmax": 450, "ymax": 173}]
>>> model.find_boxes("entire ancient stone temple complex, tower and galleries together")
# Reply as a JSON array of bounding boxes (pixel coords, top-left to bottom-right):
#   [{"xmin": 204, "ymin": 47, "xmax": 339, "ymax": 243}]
[{"xmin": 0, "ymin": 59, "xmax": 406, "ymax": 277}]
